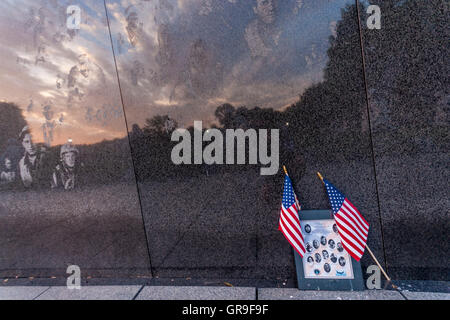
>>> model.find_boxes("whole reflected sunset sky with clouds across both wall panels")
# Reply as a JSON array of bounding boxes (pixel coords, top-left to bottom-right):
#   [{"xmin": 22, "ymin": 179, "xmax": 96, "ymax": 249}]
[{"xmin": 0, "ymin": 0, "xmax": 351, "ymax": 144}]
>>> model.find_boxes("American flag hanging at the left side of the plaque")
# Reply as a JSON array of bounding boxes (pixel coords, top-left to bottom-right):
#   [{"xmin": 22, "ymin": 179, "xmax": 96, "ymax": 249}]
[{"xmin": 278, "ymin": 174, "xmax": 305, "ymax": 258}]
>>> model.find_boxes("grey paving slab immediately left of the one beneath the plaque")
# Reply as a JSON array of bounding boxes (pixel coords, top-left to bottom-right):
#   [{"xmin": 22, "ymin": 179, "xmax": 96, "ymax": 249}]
[{"xmin": 136, "ymin": 286, "xmax": 256, "ymax": 300}]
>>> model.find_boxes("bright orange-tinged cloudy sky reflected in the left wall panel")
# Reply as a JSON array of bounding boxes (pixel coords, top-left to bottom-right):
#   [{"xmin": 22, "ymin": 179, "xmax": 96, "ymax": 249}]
[{"xmin": 0, "ymin": 0, "xmax": 126, "ymax": 144}]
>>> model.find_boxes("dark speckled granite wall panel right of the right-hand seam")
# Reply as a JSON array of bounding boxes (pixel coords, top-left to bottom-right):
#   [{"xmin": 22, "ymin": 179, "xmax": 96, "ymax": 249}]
[{"xmin": 361, "ymin": 0, "xmax": 450, "ymax": 281}]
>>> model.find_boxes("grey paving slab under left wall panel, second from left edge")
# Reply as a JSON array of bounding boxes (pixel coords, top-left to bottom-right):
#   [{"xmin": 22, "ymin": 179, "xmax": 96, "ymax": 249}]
[{"xmin": 37, "ymin": 286, "xmax": 142, "ymax": 300}]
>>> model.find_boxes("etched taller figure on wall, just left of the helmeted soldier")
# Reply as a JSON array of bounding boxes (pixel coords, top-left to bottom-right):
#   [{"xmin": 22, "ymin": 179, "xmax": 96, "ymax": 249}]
[{"xmin": 18, "ymin": 126, "xmax": 49, "ymax": 188}]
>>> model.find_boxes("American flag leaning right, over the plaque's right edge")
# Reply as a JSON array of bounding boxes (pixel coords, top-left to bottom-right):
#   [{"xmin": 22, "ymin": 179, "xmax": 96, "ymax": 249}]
[{"xmin": 323, "ymin": 180, "xmax": 369, "ymax": 261}]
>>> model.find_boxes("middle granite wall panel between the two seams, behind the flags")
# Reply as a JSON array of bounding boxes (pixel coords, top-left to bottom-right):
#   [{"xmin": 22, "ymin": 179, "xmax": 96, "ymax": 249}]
[{"xmin": 107, "ymin": 0, "xmax": 384, "ymax": 281}]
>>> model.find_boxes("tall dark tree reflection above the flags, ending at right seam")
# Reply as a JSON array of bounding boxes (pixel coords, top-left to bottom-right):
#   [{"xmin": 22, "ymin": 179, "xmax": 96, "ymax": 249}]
[{"xmin": 285, "ymin": 5, "xmax": 367, "ymax": 160}]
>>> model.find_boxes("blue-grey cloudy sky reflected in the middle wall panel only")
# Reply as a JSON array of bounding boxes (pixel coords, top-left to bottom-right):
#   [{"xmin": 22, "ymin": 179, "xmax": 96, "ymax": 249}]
[{"xmin": 108, "ymin": 0, "xmax": 345, "ymax": 126}]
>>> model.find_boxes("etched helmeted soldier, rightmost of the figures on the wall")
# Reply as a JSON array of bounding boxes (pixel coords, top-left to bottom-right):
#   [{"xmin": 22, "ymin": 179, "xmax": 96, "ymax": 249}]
[{"xmin": 51, "ymin": 141, "xmax": 82, "ymax": 190}]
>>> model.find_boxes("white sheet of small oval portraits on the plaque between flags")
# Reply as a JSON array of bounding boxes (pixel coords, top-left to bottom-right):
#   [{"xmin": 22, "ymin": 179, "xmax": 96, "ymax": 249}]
[{"xmin": 300, "ymin": 219, "xmax": 353, "ymax": 279}]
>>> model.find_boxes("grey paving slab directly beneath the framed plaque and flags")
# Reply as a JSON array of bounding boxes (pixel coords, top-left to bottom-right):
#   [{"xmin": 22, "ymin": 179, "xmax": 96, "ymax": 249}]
[{"xmin": 258, "ymin": 288, "xmax": 405, "ymax": 300}]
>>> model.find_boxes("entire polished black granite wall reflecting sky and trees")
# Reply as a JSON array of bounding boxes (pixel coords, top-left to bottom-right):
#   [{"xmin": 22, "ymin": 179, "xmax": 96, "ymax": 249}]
[{"xmin": 0, "ymin": 0, "xmax": 449, "ymax": 284}]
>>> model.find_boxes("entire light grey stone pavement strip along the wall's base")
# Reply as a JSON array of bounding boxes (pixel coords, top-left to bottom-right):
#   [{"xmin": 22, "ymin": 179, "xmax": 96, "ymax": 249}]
[{"xmin": 0, "ymin": 285, "xmax": 450, "ymax": 300}]
